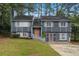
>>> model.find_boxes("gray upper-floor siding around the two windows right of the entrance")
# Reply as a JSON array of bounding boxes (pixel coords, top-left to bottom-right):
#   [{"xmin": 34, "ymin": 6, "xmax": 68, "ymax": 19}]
[{"xmin": 42, "ymin": 22, "xmax": 71, "ymax": 32}]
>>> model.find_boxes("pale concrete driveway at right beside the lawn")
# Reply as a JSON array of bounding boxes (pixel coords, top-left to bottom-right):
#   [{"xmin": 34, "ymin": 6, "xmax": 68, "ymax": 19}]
[{"xmin": 49, "ymin": 43, "xmax": 79, "ymax": 56}]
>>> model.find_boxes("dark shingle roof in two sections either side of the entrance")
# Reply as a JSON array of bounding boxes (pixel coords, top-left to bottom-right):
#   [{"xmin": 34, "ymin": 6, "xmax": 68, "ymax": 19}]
[{"xmin": 13, "ymin": 15, "xmax": 70, "ymax": 21}]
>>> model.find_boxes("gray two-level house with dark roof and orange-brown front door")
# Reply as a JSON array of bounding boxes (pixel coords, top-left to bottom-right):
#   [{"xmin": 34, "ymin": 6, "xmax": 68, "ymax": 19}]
[{"xmin": 11, "ymin": 16, "xmax": 71, "ymax": 42}]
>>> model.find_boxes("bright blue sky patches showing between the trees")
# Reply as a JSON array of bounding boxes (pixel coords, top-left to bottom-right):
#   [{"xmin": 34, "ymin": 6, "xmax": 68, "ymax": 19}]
[{"xmin": 15, "ymin": 3, "xmax": 78, "ymax": 16}]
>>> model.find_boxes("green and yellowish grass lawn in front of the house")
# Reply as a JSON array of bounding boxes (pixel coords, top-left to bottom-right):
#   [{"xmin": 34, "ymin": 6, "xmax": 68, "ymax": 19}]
[{"xmin": 0, "ymin": 39, "xmax": 59, "ymax": 56}]
